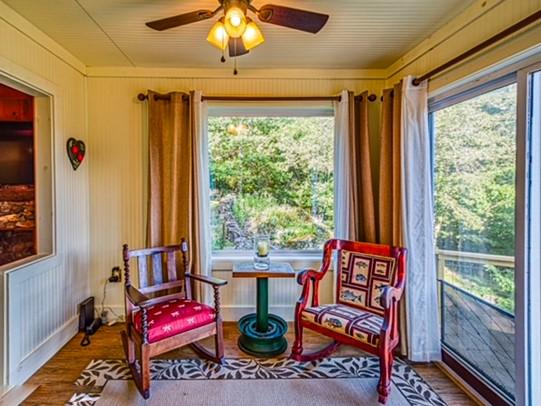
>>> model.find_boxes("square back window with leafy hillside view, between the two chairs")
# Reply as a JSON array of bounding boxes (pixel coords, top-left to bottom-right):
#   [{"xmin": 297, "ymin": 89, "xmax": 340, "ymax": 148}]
[{"xmin": 208, "ymin": 108, "xmax": 334, "ymax": 251}]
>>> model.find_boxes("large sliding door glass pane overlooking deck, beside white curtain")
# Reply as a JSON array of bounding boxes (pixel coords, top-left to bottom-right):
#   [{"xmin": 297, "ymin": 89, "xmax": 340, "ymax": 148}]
[{"xmin": 431, "ymin": 78, "xmax": 517, "ymax": 400}]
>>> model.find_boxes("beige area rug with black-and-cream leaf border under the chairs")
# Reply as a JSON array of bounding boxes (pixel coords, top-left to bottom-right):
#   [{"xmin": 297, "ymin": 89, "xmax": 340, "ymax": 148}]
[{"xmin": 67, "ymin": 357, "xmax": 445, "ymax": 406}]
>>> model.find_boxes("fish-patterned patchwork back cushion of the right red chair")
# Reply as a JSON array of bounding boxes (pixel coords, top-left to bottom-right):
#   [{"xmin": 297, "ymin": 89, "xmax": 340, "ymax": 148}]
[{"xmin": 336, "ymin": 247, "xmax": 397, "ymax": 316}]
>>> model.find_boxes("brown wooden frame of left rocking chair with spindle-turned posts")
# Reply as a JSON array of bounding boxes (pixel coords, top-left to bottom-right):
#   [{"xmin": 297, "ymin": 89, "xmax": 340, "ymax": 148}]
[{"xmin": 121, "ymin": 239, "xmax": 227, "ymax": 399}]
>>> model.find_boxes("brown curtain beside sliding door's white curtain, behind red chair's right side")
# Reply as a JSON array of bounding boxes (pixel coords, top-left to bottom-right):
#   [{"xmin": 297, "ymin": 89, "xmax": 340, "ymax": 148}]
[{"xmin": 378, "ymin": 82, "xmax": 407, "ymax": 355}]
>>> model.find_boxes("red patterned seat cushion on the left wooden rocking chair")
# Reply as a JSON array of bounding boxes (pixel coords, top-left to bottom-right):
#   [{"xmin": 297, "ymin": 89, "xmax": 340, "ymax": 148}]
[{"xmin": 133, "ymin": 299, "xmax": 216, "ymax": 343}]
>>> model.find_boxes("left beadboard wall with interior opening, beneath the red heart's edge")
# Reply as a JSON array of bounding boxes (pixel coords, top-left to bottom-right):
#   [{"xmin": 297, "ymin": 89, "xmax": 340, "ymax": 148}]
[{"xmin": 0, "ymin": 2, "xmax": 92, "ymax": 384}]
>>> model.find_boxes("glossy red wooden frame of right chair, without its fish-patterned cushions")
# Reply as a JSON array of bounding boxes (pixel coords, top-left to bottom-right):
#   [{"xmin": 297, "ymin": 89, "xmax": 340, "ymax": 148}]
[{"xmin": 291, "ymin": 239, "xmax": 407, "ymax": 403}]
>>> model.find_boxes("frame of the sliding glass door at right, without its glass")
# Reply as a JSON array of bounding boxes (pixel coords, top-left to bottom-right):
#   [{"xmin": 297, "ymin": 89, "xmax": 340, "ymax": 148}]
[{"xmin": 428, "ymin": 52, "xmax": 541, "ymax": 406}]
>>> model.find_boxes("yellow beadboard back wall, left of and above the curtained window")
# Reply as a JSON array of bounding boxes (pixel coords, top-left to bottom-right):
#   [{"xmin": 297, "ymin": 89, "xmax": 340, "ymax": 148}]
[{"xmin": 88, "ymin": 74, "xmax": 383, "ymax": 307}]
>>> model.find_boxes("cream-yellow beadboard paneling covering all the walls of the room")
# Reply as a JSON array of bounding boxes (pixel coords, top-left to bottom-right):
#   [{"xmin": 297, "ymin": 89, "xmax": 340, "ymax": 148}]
[{"xmin": 0, "ymin": 0, "xmax": 541, "ymax": 394}]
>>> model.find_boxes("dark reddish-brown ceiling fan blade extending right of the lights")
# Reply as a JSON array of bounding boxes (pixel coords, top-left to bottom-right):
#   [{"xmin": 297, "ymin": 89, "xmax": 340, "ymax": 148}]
[{"xmin": 257, "ymin": 4, "xmax": 329, "ymax": 34}]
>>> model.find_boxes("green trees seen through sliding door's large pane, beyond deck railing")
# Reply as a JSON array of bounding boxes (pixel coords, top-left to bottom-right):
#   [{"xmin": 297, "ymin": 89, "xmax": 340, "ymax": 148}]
[{"xmin": 434, "ymin": 85, "xmax": 516, "ymax": 311}]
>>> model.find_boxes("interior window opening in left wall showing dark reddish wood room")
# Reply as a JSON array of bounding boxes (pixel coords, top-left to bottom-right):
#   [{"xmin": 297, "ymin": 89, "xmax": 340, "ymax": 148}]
[{"xmin": 0, "ymin": 78, "xmax": 53, "ymax": 269}]
